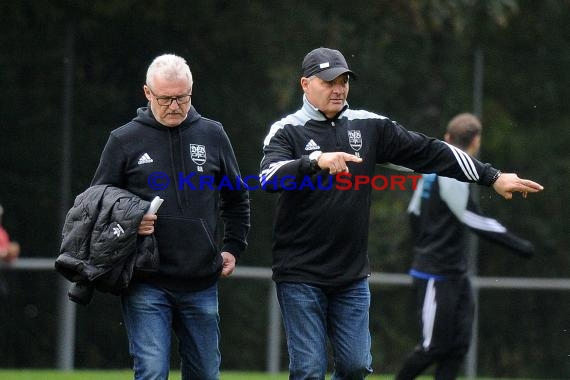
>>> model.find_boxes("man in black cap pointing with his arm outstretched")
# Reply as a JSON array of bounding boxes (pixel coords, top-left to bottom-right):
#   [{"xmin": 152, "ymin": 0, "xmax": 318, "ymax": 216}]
[{"xmin": 260, "ymin": 48, "xmax": 542, "ymax": 380}]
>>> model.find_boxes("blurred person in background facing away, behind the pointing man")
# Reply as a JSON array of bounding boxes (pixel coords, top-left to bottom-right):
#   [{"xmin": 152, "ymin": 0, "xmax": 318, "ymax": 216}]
[{"xmin": 396, "ymin": 113, "xmax": 534, "ymax": 380}]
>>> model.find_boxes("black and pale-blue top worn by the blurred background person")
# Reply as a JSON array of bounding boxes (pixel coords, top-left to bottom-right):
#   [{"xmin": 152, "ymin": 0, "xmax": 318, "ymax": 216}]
[{"xmin": 408, "ymin": 174, "xmax": 534, "ymax": 279}]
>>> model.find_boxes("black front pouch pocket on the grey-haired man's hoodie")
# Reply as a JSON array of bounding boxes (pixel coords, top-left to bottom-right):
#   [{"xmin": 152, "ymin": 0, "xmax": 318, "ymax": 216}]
[{"xmin": 155, "ymin": 215, "xmax": 222, "ymax": 278}]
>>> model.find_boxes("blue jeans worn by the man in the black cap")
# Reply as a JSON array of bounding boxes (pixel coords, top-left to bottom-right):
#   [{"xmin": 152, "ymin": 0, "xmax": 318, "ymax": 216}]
[{"xmin": 276, "ymin": 279, "xmax": 372, "ymax": 380}]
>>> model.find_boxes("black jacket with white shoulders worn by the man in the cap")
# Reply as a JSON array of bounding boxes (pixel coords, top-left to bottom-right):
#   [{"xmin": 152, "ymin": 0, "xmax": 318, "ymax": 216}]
[{"xmin": 260, "ymin": 97, "xmax": 497, "ymax": 286}]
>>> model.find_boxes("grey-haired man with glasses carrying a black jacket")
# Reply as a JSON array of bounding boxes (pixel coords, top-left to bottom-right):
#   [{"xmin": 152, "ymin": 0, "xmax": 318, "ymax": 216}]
[{"xmin": 92, "ymin": 54, "xmax": 249, "ymax": 380}]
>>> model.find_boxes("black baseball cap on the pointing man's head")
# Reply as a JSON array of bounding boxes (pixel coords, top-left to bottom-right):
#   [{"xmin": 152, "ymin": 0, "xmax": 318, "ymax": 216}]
[{"xmin": 302, "ymin": 47, "xmax": 356, "ymax": 81}]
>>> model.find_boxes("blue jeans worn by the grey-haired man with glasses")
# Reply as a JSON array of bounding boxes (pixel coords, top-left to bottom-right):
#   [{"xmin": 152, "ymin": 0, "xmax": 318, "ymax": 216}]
[{"xmin": 122, "ymin": 284, "xmax": 221, "ymax": 380}]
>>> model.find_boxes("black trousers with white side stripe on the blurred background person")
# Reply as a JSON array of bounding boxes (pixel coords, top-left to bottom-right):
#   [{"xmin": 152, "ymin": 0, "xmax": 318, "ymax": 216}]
[{"xmin": 396, "ymin": 277, "xmax": 475, "ymax": 380}]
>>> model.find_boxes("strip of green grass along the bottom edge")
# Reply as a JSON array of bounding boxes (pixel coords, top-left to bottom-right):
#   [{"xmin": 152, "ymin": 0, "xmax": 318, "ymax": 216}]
[{"xmin": 0, "ymin": 369, "xmax": 523, "ymax": 380}]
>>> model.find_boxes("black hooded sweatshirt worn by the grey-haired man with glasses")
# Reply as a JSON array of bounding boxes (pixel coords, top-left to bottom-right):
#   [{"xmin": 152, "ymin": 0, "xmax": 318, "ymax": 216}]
[{"xmin": 92, "ymin": 107, "xmax": 249, "ymax": 290}]
